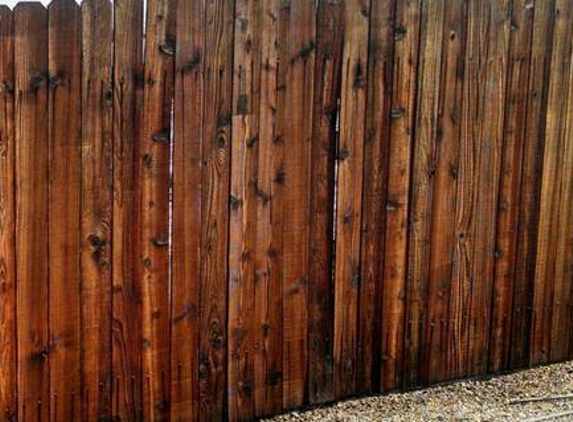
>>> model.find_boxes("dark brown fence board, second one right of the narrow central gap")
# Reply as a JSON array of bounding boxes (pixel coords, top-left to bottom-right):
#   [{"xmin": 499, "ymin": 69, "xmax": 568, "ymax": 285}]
[{"xmin": 356, "ymin": 0, "xmax": 395, "ymax": 392}]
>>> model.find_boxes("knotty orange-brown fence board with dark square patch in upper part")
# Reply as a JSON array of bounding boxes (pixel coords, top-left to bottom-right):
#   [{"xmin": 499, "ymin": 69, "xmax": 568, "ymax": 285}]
[{"xmin": 228, "ymin": 0, "xmax": 262, "ymax": 420}]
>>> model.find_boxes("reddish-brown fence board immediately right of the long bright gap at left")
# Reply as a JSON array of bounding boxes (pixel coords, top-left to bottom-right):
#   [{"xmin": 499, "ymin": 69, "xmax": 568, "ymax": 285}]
[{"xmin": 170, "ymin": 0, "xmax": 204, "ymax": 420}]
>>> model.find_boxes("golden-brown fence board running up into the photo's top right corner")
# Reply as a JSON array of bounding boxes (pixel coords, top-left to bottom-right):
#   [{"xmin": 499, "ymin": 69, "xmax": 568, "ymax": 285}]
[{"xmin": 531, "ymin": 1, "xmax": 573, "ymax": 365}]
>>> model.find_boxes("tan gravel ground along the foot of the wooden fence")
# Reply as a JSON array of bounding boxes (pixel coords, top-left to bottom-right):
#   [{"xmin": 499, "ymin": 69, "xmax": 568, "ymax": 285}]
[{"xmin": 267, "ymin": 362, "xmax": 573, "ymax": 422}]
